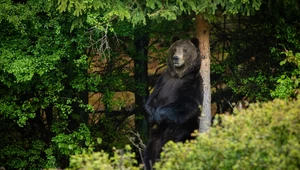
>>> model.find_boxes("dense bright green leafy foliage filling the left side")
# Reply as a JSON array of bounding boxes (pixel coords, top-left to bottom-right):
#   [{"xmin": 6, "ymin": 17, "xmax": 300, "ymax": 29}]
[{"xmin": 0, "ymin": 0, "xmax": 117, "ymax": 169}]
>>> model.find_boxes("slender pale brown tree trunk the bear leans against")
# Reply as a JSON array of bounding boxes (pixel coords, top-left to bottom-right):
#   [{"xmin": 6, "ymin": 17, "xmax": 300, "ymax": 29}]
[{"xmin": 196, "ymin": 14, "xmax": 211, "ymax": 133}]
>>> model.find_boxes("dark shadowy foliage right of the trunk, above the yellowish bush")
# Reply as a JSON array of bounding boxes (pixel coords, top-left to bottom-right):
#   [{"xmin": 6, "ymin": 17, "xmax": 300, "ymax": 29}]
[{"xmin": 211, "ymin": 1, "xmax": 300, "ymax": 105}]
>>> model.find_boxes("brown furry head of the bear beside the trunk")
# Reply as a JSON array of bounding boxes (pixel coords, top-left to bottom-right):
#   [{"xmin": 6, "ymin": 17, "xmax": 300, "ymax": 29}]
[{"xmin": 167, "ymin": 37, "xmax": 201, "ymax": 78}]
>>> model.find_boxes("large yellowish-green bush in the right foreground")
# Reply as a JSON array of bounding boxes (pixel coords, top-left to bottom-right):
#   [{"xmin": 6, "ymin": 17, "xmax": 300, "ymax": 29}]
[{"xmin": 155, "ymin": 100, "xmax": 300, "ymax": 170}]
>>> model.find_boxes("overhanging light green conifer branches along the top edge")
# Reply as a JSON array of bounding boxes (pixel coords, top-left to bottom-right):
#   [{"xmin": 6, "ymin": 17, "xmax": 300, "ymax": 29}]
[{"xmin": 58, "ymin": 0, "xmax": 262, "ymax": 30}]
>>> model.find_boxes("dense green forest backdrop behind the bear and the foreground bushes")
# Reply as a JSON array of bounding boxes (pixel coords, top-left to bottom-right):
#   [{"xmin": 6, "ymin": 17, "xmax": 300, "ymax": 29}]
[{"xmin": 0, "ymin": 0, "xmax": 300, "ymax": 169}]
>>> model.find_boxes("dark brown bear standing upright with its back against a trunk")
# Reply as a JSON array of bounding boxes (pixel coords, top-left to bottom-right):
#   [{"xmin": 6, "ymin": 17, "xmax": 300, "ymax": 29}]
[{"xmin": 144, "ymin": 37, "xmax": 203, "ymax": 170}]
